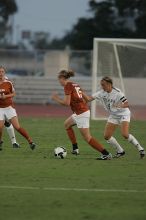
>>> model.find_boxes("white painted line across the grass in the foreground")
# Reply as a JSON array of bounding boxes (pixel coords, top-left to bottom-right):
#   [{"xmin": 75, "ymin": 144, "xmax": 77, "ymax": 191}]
[{"xmin": 0, "ymin": 186, "xmax": 146, "ymax": 193}]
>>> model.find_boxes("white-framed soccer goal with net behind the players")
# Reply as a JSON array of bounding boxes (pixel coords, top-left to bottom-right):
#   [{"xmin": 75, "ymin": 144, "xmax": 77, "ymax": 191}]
[{"xmin": 91, "ymin": 38, "xmax": 146, "ymax": 119}]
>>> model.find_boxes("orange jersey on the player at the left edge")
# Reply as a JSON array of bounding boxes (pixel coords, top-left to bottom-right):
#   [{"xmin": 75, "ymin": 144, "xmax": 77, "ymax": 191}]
[{"xmin": 0, "ymin": 80, "xmax": 15, "ymax": 108}]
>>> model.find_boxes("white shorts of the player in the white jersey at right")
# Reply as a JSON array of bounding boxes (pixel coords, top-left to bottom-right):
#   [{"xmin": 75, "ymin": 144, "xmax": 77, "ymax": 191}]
[{"xmin": 107, "ymin": 114, "xmax": 130, "ymax": 125}]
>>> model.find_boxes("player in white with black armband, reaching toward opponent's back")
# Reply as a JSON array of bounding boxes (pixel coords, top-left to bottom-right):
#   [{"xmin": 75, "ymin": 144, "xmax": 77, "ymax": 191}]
[{"xmin": 83, "ymin": 77, "xmax": 145, "ymax": 158}]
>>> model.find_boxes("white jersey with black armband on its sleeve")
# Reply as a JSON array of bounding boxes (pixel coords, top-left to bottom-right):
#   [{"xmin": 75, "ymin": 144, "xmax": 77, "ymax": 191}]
[{"xmin": 92, "ymin": 87, "xmax": 130, "ymax": 116}]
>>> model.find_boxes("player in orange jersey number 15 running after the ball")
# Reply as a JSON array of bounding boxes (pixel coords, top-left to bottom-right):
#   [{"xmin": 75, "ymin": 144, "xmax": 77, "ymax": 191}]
[{"xmin": 52, "ymin": 70, "xmax": 112, "ymax": 160}]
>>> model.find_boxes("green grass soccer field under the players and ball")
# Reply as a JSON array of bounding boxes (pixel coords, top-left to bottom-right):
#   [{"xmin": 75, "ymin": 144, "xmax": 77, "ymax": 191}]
[{"xmin": 0, "ymin": 118, "xmax": 146, "ymax": 220}]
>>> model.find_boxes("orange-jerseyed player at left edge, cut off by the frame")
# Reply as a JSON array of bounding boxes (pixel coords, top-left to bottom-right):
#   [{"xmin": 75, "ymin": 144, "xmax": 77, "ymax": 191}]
[{"xmin": 0, "ymin": 66, "xmax": 35, "ymax": 150}]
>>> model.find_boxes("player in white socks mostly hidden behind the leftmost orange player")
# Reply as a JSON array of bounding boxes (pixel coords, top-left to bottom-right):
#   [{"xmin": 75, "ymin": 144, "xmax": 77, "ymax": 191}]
[{"xmin": 0, "ymin": 76, "xmax": 20, "ymax": 150}]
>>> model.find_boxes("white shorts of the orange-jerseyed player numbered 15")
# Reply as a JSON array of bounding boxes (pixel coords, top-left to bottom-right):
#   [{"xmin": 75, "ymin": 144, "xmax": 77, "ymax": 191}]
[{"xmin": 72, "ymin": 110, "xmax": 90, "ymax": 128}]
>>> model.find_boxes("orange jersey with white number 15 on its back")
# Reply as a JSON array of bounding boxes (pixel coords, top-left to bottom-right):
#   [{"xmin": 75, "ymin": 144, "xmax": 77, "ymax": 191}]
[{"xmin": 64, "ymin": 82, "xmax": 89, "ymax": 115}]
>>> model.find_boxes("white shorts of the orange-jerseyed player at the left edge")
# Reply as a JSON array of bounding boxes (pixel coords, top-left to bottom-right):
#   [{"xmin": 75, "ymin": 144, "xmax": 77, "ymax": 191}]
[{"xmin": 0, "ymin": 106, "xmax": 17, "ymax": 121}]
